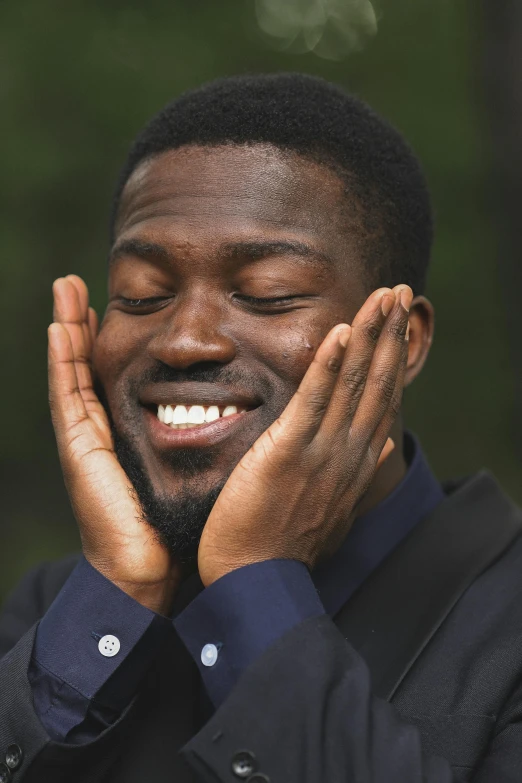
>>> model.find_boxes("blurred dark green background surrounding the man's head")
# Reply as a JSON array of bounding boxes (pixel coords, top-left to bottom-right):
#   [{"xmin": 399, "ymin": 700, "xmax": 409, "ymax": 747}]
[{"xmin": 0, "ymin": 0, "xmax": 522, "ymax": 597}]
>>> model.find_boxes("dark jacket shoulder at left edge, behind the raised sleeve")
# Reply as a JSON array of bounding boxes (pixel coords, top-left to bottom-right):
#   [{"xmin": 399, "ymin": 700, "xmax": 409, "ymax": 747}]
[{"xmin": 0, "ymin": 554, "xmax": 80, "ymax": 658}]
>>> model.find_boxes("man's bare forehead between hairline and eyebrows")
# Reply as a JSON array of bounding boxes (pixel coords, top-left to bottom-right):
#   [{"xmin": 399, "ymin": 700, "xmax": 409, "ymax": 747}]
[{"xmin": 115, "ymin": 145, "xmax": 355, "ymax": 272}]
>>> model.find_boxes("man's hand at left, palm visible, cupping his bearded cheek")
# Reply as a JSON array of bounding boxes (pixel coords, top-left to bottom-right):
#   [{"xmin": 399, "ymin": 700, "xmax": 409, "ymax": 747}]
[{"xmin": 49, "ymin": 275, "xmax": 181, "ymax": 614}]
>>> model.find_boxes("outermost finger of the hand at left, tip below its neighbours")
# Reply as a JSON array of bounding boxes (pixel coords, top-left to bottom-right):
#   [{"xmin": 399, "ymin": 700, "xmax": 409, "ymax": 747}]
[{"xmin": 48, "ymin": 323, "xmax": 87, "ymax": 442}]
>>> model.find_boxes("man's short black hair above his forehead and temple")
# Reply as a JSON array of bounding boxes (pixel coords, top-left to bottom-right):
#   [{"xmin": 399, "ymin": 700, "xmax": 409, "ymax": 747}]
[{"xmin": 111, "ymin": 73, "xmax": 433, "ymax": 294}]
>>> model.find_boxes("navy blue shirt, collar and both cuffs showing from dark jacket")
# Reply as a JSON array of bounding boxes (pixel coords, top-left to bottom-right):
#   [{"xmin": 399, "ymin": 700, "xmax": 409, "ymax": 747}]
[{"xmin": 29, "ymin": 435, "xmax": 444, "ymax": 743}]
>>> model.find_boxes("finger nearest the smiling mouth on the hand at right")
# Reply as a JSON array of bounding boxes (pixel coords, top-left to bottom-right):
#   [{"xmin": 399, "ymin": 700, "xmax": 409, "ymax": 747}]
[{"xmin": 268, "ymin": 324, "xmax": 351, "ymax": 444}]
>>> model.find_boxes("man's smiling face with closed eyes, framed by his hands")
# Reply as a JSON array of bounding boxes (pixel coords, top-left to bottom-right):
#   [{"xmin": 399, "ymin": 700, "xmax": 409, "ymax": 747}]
[{"xmin": 94, "ymin": 145, "xmax": 368, "ymax": 550}]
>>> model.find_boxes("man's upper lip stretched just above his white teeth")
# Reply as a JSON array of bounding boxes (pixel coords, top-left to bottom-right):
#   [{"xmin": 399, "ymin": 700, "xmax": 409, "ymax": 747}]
[{"xmin": 140, "ymin": 381, "xmax": 260, "ymax": 408}]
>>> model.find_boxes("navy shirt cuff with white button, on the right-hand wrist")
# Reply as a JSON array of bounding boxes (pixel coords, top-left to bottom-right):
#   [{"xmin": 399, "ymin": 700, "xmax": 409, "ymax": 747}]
[{"xmin": 174, "ymin": 560, "xmax": 325, "ymax": 707}]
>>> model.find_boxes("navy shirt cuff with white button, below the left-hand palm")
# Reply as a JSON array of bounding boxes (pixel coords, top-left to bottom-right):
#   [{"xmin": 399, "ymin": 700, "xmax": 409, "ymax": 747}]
[{"xmin": 29, "ymin": 558, "xmax": 173, "ymax": 743}]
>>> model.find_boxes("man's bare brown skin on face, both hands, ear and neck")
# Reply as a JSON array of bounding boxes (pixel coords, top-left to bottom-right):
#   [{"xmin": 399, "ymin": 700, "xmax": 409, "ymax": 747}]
[{"xmin": 50, "ymin": 145, "xmax": 433, "ymax": 612}]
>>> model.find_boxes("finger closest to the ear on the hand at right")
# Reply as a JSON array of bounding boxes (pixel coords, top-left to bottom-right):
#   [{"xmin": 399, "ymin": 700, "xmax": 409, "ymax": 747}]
[{"xmin": 349, "ymin": 286, "xmax": 413, "ymax": 444}]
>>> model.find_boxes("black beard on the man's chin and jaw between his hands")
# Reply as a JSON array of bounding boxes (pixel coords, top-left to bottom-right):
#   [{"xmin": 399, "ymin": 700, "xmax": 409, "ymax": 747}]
[{"xmin": 112, "ymin": 426, "xmax": 228, "ymax": 565}]
